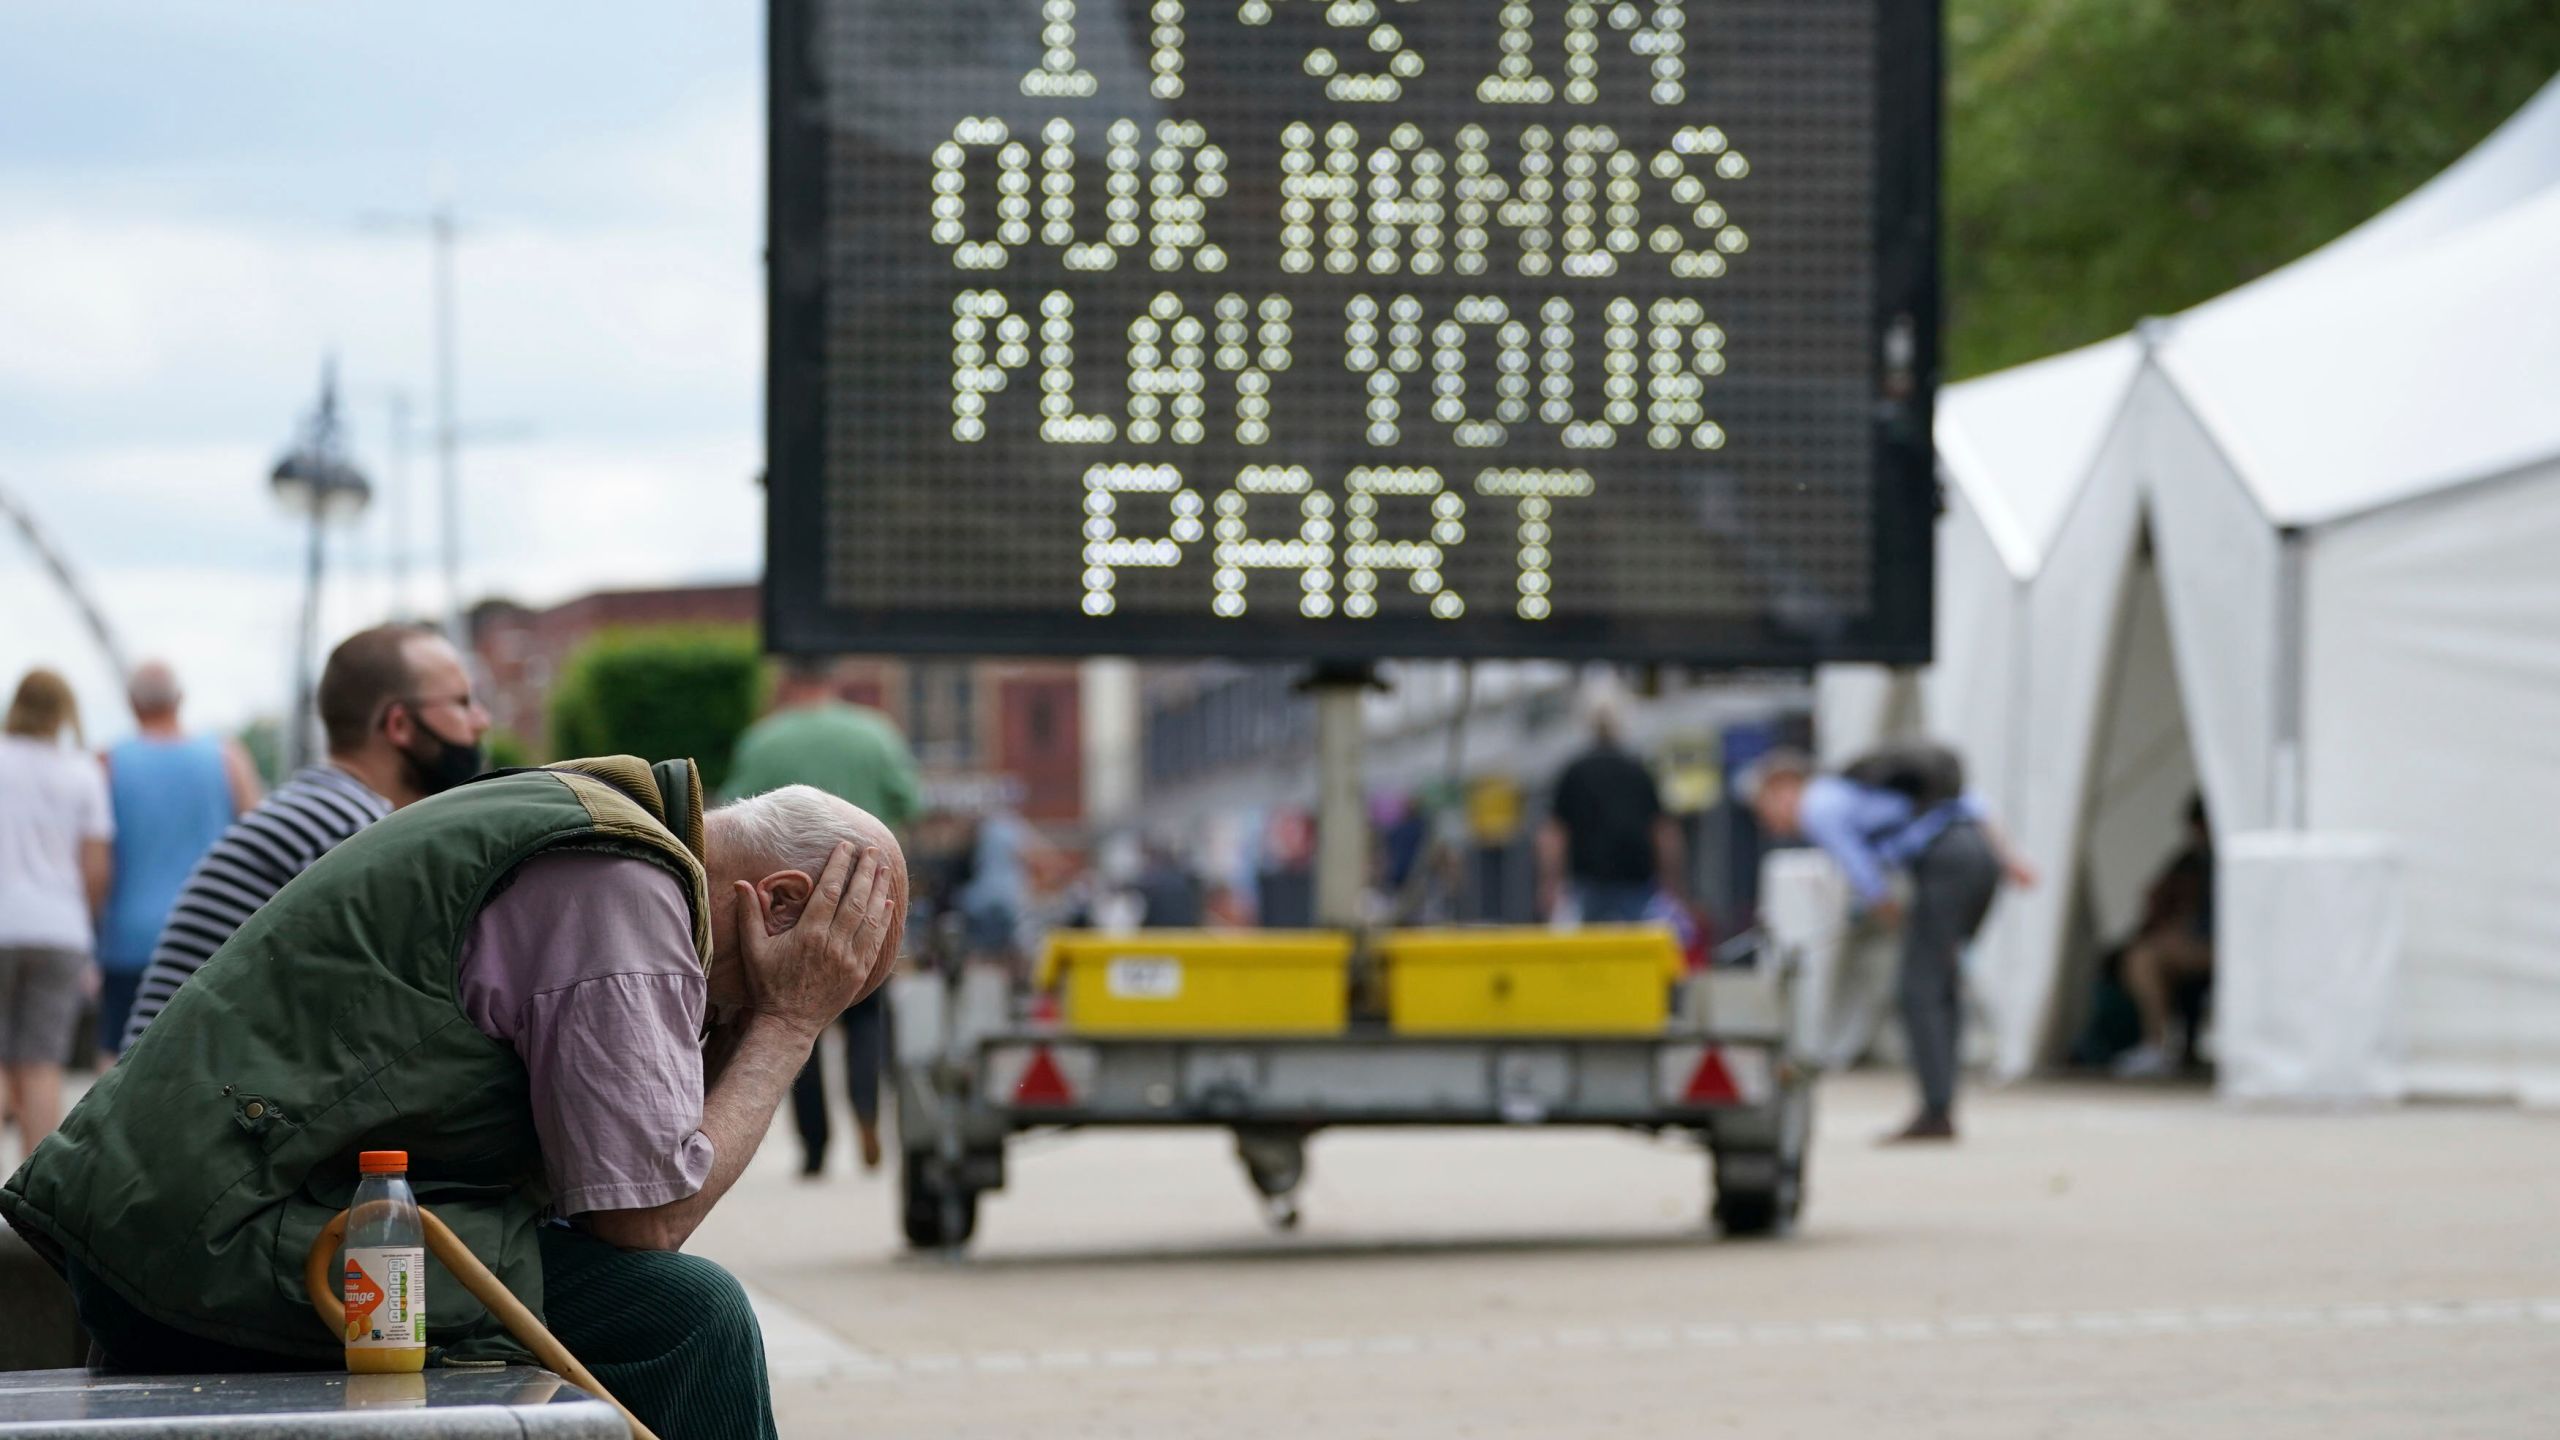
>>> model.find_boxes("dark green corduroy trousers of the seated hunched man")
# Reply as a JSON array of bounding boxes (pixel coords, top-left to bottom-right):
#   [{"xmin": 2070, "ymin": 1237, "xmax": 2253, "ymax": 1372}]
[{"xmin": 69, "ymin": 1225, "xmax": 776, "ymax": 1440}]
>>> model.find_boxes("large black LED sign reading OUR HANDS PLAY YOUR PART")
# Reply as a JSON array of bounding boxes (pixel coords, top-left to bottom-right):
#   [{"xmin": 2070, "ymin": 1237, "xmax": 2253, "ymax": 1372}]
[{"xmin": 765, "ymin": 0, "xmax": 1938, "ymax": 664}]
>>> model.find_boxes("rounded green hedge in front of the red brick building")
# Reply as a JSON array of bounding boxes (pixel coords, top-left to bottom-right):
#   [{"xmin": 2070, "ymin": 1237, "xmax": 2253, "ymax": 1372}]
[{"xmin": 550, "ymin": 625, "xmax": 765, "ymax": 792}]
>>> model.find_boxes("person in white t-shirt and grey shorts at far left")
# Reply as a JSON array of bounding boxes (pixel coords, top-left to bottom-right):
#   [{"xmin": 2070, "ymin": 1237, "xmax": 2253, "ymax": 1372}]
[{"xmin": 0, "ymin": 669, "xmax": 115, "ymax": 1150}]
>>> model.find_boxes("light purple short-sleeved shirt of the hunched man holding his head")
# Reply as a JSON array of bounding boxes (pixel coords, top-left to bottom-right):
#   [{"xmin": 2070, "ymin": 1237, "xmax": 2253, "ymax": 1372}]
[{"xmin": 461, "ymin": 851, "xmax": 712, "ymax": 1215}]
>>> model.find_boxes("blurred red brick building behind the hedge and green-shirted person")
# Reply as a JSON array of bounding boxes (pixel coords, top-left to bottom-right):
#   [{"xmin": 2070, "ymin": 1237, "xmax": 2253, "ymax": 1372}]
[{"xmin": 471, "ymin": 584, "xmax": 1085, "ymax": 825}]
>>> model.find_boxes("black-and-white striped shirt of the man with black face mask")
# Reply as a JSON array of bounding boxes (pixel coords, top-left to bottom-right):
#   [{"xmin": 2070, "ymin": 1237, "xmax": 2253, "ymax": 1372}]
[{"xmin": 123, "ymin": 766, "xmax": 392, "ymax": 1051}]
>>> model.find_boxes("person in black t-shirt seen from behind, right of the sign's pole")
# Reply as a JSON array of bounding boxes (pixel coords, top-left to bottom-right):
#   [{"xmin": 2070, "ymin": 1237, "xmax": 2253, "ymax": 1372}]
[{"xmin": 1539, "ymin": 694, "xmax": 1687, "ymax": 925}]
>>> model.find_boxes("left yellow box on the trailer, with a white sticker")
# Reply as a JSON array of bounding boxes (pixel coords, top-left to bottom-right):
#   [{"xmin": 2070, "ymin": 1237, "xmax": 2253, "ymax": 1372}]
[{"xmin": 1039, "ymin": 930, "xmax": 1352, "ymax": 1035}]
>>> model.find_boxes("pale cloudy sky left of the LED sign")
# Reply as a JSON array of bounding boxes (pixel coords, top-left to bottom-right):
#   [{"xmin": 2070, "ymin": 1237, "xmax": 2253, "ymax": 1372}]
[{"xmin": 0, "ymin": 11, "xmax": 763, "ymax": 740}]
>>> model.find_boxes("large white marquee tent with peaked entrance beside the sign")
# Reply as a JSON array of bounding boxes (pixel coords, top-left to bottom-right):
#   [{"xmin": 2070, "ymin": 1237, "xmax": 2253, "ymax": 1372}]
[{"xmin": 1818, "ymin": 82, "xmax": 2560, "ymax": 1102}]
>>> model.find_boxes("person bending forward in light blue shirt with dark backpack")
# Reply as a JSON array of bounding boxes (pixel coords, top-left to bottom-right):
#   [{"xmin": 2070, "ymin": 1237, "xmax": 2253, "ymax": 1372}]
[{"xmin": 1743, "ymin": 743, "xmax": 2035, "ymax": 1140}]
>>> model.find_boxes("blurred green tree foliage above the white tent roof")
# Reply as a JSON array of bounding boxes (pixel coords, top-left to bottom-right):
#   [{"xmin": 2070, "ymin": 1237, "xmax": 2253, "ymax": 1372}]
[{"xmin": 1946, "ymin": 0, "xmax": 2560, "ymax": 377}]
